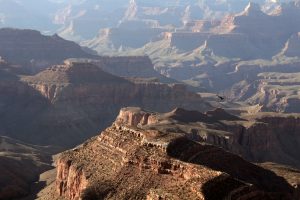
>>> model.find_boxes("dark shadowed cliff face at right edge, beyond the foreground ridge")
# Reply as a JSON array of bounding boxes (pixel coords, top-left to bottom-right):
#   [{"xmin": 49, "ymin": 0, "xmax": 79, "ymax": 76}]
[{"xmin": 237, "ymin": 115, "xmax": 300, "ymax": 168}]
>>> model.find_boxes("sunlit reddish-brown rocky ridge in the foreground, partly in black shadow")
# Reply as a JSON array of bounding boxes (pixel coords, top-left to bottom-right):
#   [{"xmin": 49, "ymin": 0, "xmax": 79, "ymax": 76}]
[{"xmin": 52, "ymin": 108, "xmax": 297, "ymax": 199}]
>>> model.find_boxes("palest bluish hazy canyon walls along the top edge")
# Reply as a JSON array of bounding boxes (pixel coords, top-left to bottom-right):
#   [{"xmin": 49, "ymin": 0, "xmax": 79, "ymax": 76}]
[{"xmin": 0, "ymin": 0, "xmax": 292, "ymax": 37}]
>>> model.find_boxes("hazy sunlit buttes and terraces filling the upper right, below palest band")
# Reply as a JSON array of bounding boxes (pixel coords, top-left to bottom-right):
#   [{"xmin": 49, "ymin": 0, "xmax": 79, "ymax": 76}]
[{"xmin": 81, "ymin": 1, "xmax": 300, "ymax": 112}]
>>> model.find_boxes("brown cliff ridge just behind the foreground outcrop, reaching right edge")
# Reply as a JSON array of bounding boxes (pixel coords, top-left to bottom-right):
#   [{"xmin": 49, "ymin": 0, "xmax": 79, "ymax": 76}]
[{"xmin": 130, "ymin": 109, "xmax": 300, "ymax": 168}]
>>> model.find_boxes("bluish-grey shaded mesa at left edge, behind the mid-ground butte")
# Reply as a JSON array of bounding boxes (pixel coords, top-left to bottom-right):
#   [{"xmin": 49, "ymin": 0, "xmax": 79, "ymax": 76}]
[{"xmin": 0, "ymin": 28, "xmax": 94, "ymax": 71}]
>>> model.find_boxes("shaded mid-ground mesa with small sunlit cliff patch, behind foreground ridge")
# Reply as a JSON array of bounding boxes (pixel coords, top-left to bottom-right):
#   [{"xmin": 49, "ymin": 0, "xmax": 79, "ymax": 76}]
[{"xmin": 0, "ymin": 62, "xmax": 210, "ymax": 147}]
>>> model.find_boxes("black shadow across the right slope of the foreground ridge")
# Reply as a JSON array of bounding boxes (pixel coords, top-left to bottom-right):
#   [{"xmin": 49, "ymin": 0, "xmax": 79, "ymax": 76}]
[{"xmin": 167, "ymin": 137, "xmax": 293, "ymax": 199}]
